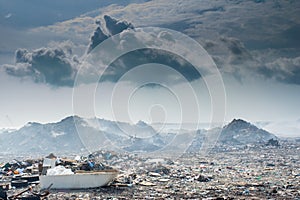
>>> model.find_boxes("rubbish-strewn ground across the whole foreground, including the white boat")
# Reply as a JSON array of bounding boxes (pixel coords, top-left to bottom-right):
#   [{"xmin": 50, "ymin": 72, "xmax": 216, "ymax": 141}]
[{"xmin": 0, "ymin": 141, "xmax": 300, "ymax": 200}]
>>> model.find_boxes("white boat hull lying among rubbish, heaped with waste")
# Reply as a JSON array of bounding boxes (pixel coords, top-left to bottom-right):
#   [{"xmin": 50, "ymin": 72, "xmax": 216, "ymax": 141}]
[{"xmin": 40, "ymin": 170, "xmax": 118, "ymax": 189}]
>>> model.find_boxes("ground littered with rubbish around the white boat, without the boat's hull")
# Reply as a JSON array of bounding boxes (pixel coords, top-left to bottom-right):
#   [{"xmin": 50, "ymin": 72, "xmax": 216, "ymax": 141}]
[{"xmin": 0, "ymin": 142, "xmax": 300, "ymax": 199}]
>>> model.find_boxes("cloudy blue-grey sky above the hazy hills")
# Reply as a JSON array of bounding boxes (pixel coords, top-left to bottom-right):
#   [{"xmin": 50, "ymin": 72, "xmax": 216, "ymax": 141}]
[{"xmin": 0, "ymin": 0, "xmax": 300, "ymax": 131}]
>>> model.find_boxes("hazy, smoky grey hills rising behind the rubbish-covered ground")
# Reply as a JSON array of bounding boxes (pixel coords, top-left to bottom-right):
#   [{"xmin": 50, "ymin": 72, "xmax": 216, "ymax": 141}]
[{"xmin": 0, "ymin": 116, "xmax": 277, "ymax": 154}]
